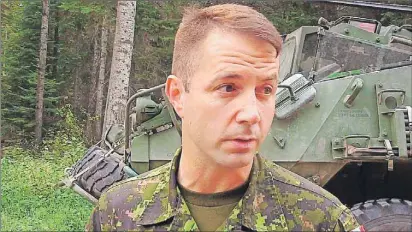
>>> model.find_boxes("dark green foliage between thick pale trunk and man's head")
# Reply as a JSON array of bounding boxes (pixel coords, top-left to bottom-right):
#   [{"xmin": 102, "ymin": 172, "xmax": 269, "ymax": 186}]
[{"xmin": 133, "ymin": 0, "xmax": 185, "ymax": 88}]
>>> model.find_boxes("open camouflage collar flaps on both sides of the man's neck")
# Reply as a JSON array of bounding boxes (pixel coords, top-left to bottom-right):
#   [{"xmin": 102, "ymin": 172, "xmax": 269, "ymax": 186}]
[{"xmin": 134, "ymin": 148, "xmax": 288, "ymax": 231}]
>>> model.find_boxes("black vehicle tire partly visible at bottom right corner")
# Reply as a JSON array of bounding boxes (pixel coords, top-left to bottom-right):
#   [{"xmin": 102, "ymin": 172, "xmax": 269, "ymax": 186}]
[{"xmin": 351, "ymin": 198, "xmax": 412, "ymax": 231}]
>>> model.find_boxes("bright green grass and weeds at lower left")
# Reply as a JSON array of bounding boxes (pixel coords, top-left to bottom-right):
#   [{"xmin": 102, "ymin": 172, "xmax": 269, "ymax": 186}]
[{"xmin": 1, "ymin": 144, "xmax": 93, "ymax": 231}]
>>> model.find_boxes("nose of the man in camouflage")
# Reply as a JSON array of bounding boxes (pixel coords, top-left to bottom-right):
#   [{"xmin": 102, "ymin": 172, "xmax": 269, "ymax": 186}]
[{"xmin": 236, "ymin": 93, "xmax": 260, "ymax": 125}]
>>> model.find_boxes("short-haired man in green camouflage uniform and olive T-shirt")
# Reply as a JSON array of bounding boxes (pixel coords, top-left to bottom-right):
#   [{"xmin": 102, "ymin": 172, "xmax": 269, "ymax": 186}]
[{"xmin": 86, "ymin": 4, "xmax": 358, "ymax": 231}]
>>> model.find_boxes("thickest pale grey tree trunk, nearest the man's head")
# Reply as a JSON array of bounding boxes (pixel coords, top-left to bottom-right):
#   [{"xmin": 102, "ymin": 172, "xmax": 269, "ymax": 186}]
[{"xmin": 103, "ymin": 1, "xmax": 136, "ymax": 140}]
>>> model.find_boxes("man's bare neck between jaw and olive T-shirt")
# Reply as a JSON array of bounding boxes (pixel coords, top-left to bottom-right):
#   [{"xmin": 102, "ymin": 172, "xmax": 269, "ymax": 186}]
[{"xmin": 178, "ymin": 148, "xmax": 252, "ymax": 193}]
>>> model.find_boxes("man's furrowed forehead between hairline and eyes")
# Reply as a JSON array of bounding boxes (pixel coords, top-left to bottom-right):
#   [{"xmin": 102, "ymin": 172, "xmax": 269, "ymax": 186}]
[{"xmin": 190, "ymin": 29, "xmax": 279, "ymax": 86}]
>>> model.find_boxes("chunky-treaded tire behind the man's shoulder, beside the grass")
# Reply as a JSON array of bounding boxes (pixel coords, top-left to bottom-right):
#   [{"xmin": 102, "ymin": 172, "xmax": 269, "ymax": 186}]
[{"xmin": 71, "ymin": 146, "xmax": 127, "ymax": 199}]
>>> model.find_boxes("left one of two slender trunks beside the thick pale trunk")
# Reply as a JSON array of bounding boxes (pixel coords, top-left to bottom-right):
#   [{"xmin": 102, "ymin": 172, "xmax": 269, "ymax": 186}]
[{"xmin": 86, "ymin": 27, "xmax": 99, "ymax": 143}]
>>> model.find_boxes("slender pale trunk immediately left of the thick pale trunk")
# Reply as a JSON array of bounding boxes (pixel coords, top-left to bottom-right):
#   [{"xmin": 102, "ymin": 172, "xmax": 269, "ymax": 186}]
[{"xmin": 93, "ymin": 18, "xmax": 108, "ymax": 140}]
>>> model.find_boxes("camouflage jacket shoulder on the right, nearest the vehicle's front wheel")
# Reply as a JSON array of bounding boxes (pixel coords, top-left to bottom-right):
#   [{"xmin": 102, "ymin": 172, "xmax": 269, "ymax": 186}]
[{"xmin": 265, "ymin": 161, "xmax": 359, "ymax": 231}]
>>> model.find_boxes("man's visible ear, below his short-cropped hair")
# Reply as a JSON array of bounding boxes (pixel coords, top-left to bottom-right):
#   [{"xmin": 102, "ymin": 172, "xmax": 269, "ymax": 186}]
[{"xmin": 165, "ymin": 75, "xmax": 185, "ymax": 119}]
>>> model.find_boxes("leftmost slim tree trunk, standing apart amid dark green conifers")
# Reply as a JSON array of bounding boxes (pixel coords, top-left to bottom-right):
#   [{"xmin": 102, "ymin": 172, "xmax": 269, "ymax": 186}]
[{"xmin": 35, "ymin": 0, "xmax": 49, "ymax": 144}]
